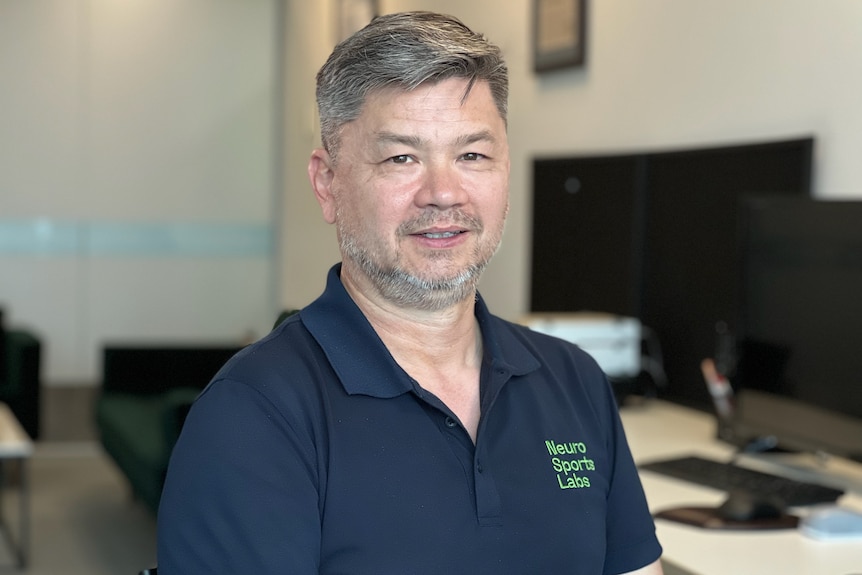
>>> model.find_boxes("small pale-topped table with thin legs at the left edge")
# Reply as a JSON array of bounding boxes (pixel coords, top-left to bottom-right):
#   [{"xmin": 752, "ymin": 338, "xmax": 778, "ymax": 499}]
[{"xmin": 0, "ymin": 403, "xmax": 33, "ymax": 569}]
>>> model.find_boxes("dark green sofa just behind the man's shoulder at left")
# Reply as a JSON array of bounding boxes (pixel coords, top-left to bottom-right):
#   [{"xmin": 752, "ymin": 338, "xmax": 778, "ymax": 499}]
[{"xmin": 95, "ymin": 345, "xmax": 241, "ymax": 513}]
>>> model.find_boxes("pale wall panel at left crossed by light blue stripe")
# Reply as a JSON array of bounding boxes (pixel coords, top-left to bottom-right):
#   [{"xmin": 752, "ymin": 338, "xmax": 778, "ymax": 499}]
[{"xmin": 0, "ymin": 0, "xmax": 281, "ymax": 385}]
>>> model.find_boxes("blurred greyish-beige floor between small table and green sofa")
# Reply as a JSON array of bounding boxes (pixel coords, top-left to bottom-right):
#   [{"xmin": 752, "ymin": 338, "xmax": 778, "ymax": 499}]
[{"xmin": 0, "ymin": 386, "xmax": 156, "ymax": 575}]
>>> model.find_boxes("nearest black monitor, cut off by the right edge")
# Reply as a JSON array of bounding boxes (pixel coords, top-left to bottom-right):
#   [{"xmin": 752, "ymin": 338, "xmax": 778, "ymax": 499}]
[{"xmin": 732, "ymin": 197, "xmax": 862, "ymax": 461}]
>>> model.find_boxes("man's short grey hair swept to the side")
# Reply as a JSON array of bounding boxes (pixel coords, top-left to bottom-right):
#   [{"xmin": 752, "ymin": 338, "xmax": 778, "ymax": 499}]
[{"xmin": 317, "ymin": 11, "xmax": 509, "ymax": 162}]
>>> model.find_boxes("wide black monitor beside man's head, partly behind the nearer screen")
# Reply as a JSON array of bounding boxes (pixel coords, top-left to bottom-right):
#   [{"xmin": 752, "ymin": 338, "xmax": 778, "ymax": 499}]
[{"xmin": 530, "ymin": 137, "xmax": 814, "ymax": 409}]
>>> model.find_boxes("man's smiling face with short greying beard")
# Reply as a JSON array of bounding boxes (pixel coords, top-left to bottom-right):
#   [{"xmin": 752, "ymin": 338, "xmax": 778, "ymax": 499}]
[{"xmin": 312, "ymin": 79, "xmax": 509, "ymax": 310}]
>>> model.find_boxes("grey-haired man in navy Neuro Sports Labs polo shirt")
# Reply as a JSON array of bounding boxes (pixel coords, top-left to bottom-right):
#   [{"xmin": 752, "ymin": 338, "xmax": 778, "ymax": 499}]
[{"xmin": 159, "ymin": 12, "xmax": 661, "ymax": 575}]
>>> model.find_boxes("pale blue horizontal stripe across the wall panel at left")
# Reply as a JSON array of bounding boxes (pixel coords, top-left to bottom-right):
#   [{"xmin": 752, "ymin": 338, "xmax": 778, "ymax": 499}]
[{"xmin": 0, "ymin": 219, "xmax": 273, "ymax": 258}]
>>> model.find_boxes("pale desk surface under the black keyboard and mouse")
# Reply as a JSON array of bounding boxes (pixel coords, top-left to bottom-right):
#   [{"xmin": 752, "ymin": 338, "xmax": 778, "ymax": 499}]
[{"xmin": 621, "ymin": 400, "xmax": 862, "ymax": 575}]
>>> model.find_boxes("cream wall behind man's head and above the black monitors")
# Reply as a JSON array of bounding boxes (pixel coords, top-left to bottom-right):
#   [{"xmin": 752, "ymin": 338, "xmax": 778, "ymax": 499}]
[{"xmin": 282, "ymin": 0, "xmax": 862, "ymax": 318}]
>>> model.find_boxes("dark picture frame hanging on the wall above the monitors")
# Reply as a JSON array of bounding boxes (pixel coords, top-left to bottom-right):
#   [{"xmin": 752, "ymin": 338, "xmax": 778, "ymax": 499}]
[{"xmin": 533, "ymin": 0, "xmax": 587, "ymax": 72}]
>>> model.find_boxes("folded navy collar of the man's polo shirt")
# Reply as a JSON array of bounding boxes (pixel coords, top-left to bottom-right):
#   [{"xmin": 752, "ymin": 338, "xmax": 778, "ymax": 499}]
[{"xmin": 300, "ymin": 264, "xmax": 539, "ymax": 398}]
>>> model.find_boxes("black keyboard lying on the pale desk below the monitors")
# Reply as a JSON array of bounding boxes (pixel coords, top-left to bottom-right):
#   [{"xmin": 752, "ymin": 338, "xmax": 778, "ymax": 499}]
[{"xmin": 639, "ymin": 456, "xmax": 844, "ymax": 507}]
